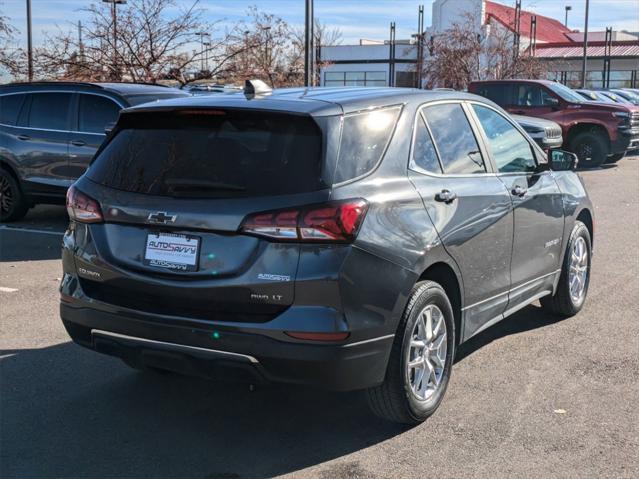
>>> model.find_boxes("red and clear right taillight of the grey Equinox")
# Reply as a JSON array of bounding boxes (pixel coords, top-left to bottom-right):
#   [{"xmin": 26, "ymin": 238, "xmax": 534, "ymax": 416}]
[{"xmin": 240, "ymin": 199, "xmax": 368, "ymax": 243}]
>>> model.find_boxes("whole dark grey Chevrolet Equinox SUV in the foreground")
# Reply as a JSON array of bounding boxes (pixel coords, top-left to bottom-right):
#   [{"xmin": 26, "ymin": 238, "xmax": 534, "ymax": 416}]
[{"xmin": 60, "ymin": 88, "xmax": 594, "ymax": 423}]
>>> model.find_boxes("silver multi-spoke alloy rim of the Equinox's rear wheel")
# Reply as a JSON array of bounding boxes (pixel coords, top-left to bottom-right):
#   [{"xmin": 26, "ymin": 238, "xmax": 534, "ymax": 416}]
[{"xmin": 406, "ymin": 304, "xmax": 448, "ymax": 401}]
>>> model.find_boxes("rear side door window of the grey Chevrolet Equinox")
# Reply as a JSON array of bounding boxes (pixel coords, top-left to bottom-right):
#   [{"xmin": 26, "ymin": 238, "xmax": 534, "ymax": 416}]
[{"xmin": 423, "ymin": 103, "xmax": 486, "ymax": 175}]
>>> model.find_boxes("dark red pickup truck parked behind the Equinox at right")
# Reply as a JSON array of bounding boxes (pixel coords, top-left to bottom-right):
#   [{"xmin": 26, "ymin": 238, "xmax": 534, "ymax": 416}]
[{"xmin": 469, "ymin": 80, "xmax": 639, "ymax": 168}]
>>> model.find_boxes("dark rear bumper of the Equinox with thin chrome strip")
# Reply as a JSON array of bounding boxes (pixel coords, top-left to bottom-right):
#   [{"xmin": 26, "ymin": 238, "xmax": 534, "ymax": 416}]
[{"xmin": 60, "ymin": 301, "xmax": 393, "ymax": 391}]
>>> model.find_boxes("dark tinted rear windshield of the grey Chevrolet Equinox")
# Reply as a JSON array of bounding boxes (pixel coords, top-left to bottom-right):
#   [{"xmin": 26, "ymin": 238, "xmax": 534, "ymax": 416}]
[{"xmin": 87, "ymin": 110, "xmax": 326, "ymax": 198}]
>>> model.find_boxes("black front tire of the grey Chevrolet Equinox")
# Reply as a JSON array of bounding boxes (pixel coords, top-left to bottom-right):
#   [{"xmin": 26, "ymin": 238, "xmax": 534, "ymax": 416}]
[{"xmin": 540, "ymin": 221, "xmax": 592, "ymax": 317}]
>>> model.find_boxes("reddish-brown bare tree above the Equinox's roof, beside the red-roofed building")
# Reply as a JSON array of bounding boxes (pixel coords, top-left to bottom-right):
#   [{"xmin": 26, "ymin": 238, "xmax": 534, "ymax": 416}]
[{"xmin": 423, "ymin": 16, "xmax": 546, "ymax": 89}]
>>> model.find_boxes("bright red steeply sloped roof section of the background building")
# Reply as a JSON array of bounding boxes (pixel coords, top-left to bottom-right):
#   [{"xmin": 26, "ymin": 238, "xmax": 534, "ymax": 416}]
[{"xmin": 484, "ymin": 0, "xmax": 571, "ymax": 42}]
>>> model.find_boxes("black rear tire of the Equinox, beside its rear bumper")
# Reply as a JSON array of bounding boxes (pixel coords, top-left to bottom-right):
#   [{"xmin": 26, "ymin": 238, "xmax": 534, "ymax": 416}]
[{"xmin": 366, "ymin": 281, "xmax": 456, "ymax": 425}]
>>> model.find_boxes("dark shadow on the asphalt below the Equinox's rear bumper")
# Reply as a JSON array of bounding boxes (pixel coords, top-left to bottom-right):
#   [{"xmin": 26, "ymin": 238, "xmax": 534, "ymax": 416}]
[{"xmin": 0, "ymin": 343, "xmax": 406, "ymax": 479}]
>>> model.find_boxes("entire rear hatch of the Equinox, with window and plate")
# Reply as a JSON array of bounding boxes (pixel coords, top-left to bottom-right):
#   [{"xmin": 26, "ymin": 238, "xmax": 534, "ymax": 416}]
[{"xmin": 77, "ymin": 109, "xmax": 330, "ymax": 322}]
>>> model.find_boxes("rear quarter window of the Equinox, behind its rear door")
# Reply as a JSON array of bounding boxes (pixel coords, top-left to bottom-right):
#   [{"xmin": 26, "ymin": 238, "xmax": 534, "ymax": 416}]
[{"xmin": 335, "ymin": 106, "xmax": 401, "ymax": 183}]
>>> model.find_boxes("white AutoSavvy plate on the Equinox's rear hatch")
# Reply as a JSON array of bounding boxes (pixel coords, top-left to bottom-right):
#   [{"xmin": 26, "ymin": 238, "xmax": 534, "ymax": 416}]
[{"xmin": 143, "ymin": 232, "xmax": 201, "ymax": 272}]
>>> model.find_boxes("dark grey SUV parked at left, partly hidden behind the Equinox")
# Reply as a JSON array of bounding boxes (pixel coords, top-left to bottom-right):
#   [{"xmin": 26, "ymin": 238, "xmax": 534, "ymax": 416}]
[{"xmin": 0, "ymin": 82, "xmax": 187, "ymax": 221}]
